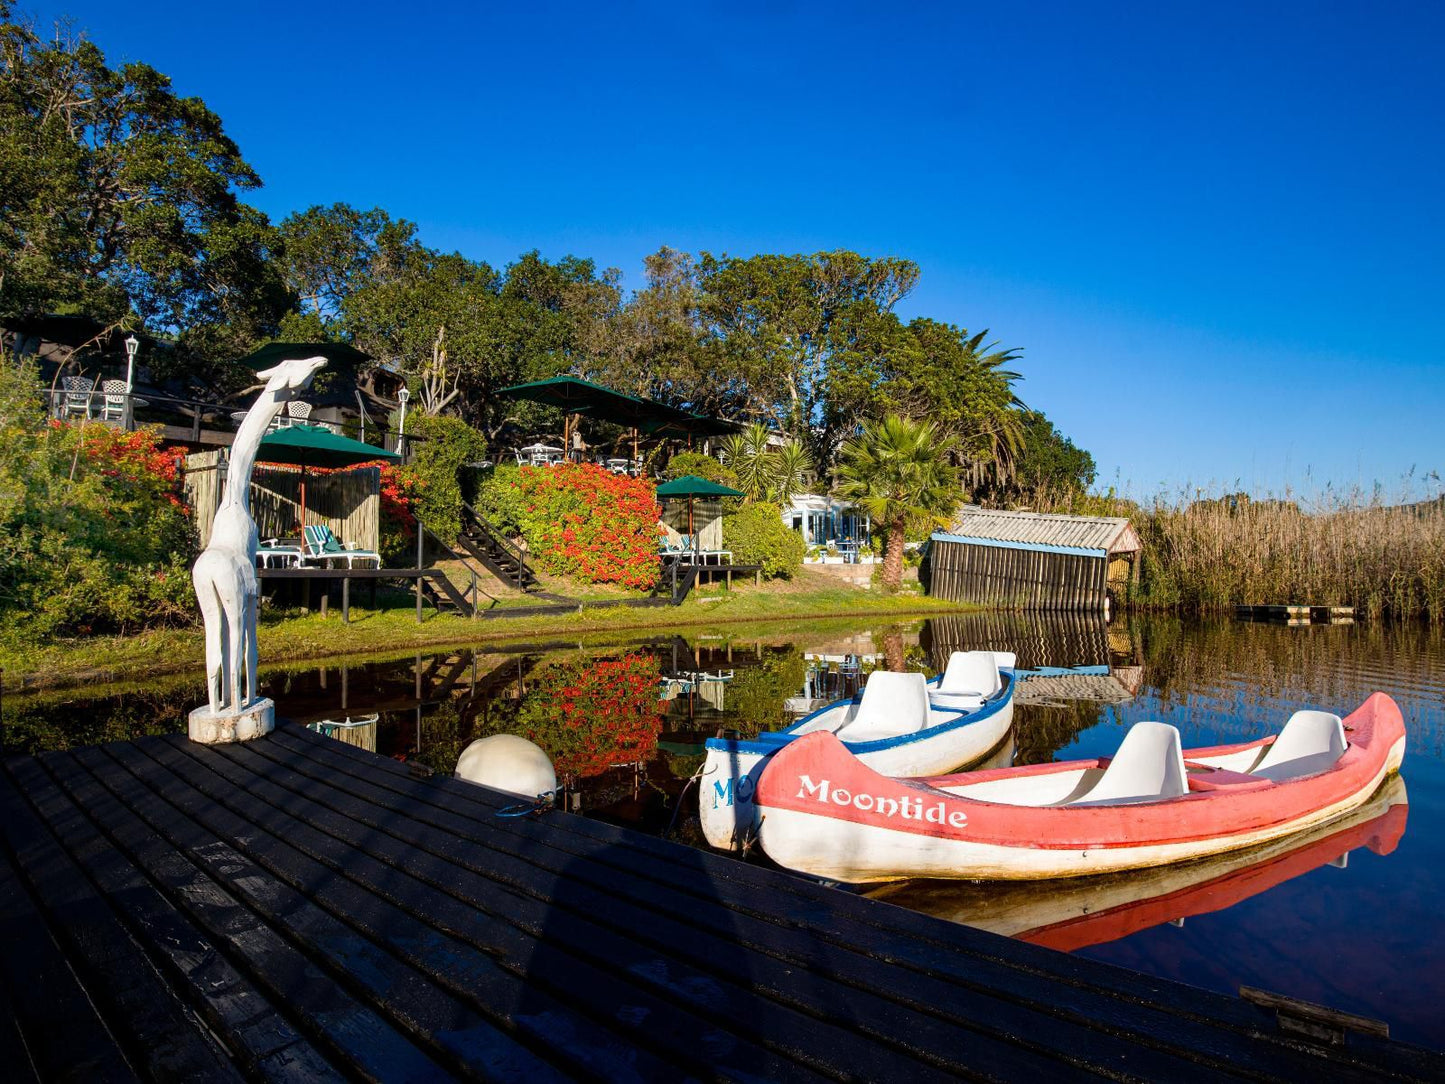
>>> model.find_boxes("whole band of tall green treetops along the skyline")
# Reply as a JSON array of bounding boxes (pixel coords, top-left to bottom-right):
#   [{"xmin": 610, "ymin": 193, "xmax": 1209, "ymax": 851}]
[{"xmin": 0, "ymin": 10, "xmax": 1092, "ymax": 494}]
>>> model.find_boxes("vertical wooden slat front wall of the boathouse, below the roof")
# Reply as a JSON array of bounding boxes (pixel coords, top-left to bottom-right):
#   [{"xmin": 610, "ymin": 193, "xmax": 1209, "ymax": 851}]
[{"xmin": 926, "ymin": 539, "xmax": 1108, "ymax": 610}]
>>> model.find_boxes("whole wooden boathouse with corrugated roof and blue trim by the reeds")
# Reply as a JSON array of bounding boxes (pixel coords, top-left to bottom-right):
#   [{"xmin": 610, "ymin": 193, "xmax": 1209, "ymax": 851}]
[{"xmin": 919, "ymin": 504, "xmax": 1140, "ymax": 610}]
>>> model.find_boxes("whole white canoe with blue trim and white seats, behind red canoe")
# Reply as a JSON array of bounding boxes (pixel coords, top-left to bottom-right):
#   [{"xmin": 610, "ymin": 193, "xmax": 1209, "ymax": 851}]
[{"xmin": 698, "ymin": 652, "xmax": 1014, "ymax": 850}]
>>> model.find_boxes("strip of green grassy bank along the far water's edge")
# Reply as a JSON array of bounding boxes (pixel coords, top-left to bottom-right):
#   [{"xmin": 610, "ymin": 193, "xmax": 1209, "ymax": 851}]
[{"xmin": 0, "ymin": 571, "xmax": 959, "ymax": 689}]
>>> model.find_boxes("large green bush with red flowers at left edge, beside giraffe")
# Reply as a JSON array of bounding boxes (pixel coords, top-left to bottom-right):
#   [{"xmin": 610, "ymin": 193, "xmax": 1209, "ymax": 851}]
[{"xmin": 0, "ymin": 361, "xmax": 197, "ymax": 643}]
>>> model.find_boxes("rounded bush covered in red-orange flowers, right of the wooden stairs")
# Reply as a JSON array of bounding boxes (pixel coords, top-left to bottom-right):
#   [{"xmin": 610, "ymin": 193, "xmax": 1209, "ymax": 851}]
[{"xmin": 481, "ymin": 463, "xmax": 660, "ymax": 591}]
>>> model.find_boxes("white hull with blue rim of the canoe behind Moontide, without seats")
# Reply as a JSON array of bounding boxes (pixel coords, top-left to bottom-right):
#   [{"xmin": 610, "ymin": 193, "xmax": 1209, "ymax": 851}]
[{"xmin": 698, "ymin": 674, "xmax": 1014, "ymax": 850}]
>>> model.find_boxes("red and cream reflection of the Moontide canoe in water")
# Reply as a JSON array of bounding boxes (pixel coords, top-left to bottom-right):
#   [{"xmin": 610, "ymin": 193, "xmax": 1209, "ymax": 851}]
[{"xmin": 868, "ymin": 776, "xmax": 1409, "ymax": 951}]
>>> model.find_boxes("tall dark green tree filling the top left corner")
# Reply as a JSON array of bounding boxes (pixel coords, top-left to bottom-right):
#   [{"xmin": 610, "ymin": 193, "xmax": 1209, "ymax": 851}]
[{"xmin": 0, "ymin": 0, "xmax": 288, "ymax": 363}]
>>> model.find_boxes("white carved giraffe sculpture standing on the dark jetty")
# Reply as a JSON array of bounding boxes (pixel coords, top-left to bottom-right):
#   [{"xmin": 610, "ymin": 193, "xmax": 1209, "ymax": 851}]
[{"xmin": 189, "ymin": 357, "xmax": 327, "ymax": 743}]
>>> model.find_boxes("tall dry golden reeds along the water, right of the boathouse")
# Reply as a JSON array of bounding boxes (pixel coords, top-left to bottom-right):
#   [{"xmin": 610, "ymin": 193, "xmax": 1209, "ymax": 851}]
[{"xmin": 1130, "ymin": 497, "xmax": 1445, "ymax": 623}]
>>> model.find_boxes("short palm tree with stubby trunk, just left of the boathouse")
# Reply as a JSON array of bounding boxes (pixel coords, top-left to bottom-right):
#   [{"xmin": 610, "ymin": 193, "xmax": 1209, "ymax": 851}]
[{"xmin": 837, "ymin": 415, "xmax": 958, "ymax": 590}]
